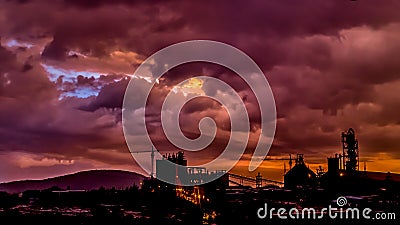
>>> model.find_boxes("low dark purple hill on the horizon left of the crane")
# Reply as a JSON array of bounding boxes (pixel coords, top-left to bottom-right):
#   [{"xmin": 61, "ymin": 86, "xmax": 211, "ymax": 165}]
[{"xmin": 0, "ymin": 170, "xmax": 144, "ymax": 193}]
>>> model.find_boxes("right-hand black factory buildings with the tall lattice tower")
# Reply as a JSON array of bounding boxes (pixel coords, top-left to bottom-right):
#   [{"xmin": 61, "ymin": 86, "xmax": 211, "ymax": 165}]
[{"xmin": 284, "ymin": 128, "xmax": 400, "ymax": 194}]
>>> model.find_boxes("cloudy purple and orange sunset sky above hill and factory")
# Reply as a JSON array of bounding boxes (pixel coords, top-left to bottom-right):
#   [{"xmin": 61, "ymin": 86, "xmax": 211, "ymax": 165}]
[{"xmin": 0, "ymin": 0, "xmax": 400, "ymax": 182}]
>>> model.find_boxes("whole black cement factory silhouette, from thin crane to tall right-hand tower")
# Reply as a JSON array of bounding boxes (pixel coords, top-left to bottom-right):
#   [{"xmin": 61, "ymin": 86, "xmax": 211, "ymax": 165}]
[{"xmin": 145, "ymin": 128, "xmax": 400, "ymax": 192}]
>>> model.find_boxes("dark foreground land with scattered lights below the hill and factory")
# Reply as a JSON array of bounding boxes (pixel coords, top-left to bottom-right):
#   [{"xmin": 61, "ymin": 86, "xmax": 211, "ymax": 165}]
[{"xmin": 0, "ymin": 186, "xmax": 400, "ymax": 225}]
